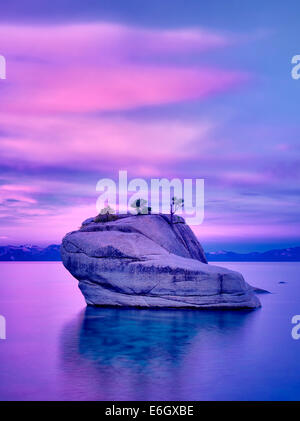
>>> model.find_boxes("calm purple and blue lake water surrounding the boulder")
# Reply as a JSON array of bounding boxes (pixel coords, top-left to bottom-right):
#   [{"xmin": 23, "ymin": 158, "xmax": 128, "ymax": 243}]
[{"xmin": 0, "ymin": 262, "xmax": 300, "ymax": 400}]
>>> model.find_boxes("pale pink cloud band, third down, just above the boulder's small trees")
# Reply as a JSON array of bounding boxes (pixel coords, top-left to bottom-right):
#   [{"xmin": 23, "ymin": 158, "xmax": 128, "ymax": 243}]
[{"xmin": 0, "ymin": 114, "xmax": 214, "ymax": 169}]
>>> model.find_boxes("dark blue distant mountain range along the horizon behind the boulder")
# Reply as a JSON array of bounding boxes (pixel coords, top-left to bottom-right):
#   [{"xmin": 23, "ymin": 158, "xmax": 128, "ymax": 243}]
[{"xmin": 0, "ymin": 244, "xmax": 300, "ymax": 262}]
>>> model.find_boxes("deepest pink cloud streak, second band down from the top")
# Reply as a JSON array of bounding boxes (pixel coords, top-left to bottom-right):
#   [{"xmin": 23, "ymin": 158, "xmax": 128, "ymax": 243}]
[{"xmin": 0, "ymin": 64, "xmax": 245, "ymax": 113}]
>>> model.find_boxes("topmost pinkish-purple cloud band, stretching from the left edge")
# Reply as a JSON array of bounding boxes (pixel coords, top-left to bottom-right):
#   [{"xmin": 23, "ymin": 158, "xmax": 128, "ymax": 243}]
[{"xmin": 0, "ymin": 22, "xmax": 232, "ymax": 62}]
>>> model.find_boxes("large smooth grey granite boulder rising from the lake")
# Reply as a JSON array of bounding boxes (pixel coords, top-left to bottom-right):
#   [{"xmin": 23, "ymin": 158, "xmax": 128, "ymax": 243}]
[{"xmin": 61, "ymin": 215, "xmax": 260, "ymax": 308}]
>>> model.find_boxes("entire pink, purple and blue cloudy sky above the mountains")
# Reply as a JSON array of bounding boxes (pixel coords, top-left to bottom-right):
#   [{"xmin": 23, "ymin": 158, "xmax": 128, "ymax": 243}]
[{"xmin": 0, "ymin": 0, "xmax": 300, "ymax": 252}]
